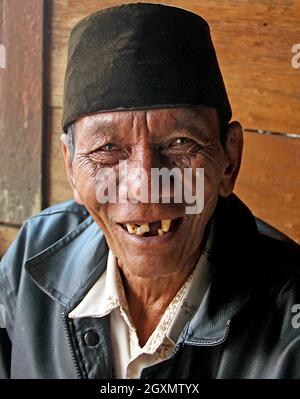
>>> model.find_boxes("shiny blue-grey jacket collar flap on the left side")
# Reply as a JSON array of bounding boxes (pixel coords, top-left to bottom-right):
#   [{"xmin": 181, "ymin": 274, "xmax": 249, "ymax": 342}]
[{"xmin": 25, "ymin": 216, "xmax": 108, "ymax": 309}]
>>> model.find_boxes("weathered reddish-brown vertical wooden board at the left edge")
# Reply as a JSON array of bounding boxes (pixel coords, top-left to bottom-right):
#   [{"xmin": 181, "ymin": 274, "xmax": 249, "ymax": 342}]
[{"xmin": 0, "ymin": 0, "xmax": 44, "ymax": 224}]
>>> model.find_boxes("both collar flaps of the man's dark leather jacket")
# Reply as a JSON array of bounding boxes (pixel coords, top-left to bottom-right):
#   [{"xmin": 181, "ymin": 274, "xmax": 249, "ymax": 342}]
[{"xmin": 26, "ymin": 195, "xmax": 257, "ymax": 345}]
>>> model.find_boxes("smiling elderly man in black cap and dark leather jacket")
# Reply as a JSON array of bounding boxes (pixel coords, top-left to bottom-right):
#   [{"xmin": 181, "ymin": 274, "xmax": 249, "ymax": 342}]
[{"xmin": 0, "ymin": 3, "xmax": 300, "ymax": 379}]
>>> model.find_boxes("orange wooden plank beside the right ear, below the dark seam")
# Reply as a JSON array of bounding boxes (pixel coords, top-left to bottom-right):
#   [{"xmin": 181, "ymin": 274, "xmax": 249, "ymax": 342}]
[{"xmin": 235, "ymin": 133, "xmax": 300, "ymax": 243}]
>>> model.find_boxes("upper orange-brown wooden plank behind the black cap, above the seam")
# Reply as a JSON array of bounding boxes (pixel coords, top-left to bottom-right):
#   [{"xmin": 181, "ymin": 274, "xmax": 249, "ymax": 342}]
[{"xmin": 50, "ymin": 0, "xmax": 300, "ymax": 134}]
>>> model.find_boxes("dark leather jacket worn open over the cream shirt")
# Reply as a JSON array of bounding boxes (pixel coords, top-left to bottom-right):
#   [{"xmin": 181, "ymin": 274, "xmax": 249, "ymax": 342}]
[{"xmin": 0, "ymin": 196, "xmax": 300, "ymax": 378}]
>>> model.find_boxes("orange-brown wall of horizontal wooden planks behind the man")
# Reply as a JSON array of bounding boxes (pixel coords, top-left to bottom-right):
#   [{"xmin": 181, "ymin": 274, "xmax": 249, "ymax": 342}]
[{"xmin": 0, "ymin": 0, "xmax": 300, "ymax": 251}]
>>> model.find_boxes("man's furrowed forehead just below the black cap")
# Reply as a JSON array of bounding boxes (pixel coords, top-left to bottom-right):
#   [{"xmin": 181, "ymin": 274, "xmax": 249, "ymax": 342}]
[{"xmin": 75, "ymin": 106, "xmax": 219, "ymax": 146}]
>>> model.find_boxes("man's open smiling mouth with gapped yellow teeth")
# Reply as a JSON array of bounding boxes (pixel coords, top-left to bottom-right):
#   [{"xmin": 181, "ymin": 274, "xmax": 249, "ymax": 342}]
[{"xmin": 118, "ymin": 217, "xmax": 182, "ymax": 238}]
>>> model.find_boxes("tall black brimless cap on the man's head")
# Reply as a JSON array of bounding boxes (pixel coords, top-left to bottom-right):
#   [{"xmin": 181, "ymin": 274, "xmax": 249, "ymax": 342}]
[{"xmin": 62, "ymin": 3, "xmax": 232, "ymax": 132}]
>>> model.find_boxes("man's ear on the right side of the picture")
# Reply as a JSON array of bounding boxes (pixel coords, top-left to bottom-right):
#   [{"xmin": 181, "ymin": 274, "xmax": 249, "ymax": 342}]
[{"xmin": 219, "ymin": 121, "xmax": 244, "ymax": 197}]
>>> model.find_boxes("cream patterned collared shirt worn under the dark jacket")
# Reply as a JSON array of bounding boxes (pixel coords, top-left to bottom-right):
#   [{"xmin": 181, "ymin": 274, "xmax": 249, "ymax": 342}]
[{"xmin": 69, "ymin": 251, "xmax": 209, "ymax": 378}]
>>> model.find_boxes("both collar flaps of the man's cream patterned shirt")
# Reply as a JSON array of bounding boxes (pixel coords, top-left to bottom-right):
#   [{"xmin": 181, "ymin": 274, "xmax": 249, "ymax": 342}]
[{"xmin": 69, "ymin": 250, "xmax": 209, "ymax": 354}]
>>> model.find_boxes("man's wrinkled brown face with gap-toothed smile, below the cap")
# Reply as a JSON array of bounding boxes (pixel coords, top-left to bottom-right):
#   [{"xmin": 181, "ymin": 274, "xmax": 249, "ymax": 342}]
[{"xmin": 64, "ymin": 107, "xmax": 242, "ymax": 277}]
